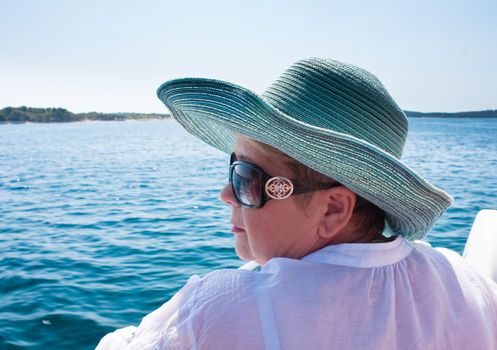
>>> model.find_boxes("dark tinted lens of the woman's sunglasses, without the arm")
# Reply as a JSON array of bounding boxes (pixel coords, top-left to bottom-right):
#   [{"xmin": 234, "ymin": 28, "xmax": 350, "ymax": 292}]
[{"xmin": 231, "ymin": 164, "xmax": 262, "ymax": 207}]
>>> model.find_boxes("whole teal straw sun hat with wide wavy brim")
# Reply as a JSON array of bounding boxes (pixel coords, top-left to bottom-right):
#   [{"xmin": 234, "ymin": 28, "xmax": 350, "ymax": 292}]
[{"xmin": 157, "ymin": 58, "xmax": 452, "ymax": 240}]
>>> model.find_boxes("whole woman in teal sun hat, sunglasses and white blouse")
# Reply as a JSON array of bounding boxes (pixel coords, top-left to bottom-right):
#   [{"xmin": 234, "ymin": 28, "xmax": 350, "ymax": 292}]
[{"xmin": 98, "ymin": 58, "xmax": 497, "ymax": 349}]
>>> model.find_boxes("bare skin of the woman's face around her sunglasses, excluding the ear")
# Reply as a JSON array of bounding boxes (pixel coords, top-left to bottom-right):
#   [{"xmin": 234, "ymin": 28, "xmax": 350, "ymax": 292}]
[{"xmin": 220, "ymin": 138, "xmax": 323, "ymax": 264}]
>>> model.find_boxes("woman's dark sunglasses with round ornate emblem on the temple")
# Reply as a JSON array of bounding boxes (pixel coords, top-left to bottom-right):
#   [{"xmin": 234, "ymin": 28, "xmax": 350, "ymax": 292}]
[{"xmin": 229, "ymin": 153, "xmax": 341, "ymax": 209}]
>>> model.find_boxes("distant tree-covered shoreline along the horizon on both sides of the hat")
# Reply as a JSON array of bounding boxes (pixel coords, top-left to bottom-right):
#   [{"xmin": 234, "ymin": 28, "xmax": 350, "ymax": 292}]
[{"xmin": 0, "ymin": 106, "xmax": 497, "ymax": 124}]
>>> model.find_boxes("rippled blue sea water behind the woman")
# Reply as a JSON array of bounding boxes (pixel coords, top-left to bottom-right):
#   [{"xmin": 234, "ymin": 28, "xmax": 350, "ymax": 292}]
[{"xmin": 0, "ymin": 119, "xmax": 497, "ymax": 349}]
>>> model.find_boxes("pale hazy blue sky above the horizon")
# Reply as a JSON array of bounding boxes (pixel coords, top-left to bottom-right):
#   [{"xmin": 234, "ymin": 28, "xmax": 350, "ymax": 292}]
[{"xmin": 0, "ymin": 0, "xmax": 497, "ymax": 113}]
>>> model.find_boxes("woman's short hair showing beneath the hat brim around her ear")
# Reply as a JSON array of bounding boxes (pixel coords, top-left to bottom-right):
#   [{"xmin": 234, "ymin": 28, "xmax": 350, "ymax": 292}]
[{"xmin": 238, "ymin": 135, "xmax": 385, "ymax": 234}]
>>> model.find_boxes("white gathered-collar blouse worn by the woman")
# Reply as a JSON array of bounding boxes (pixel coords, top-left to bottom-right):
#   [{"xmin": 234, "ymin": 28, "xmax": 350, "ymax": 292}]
[{"xmin": 97, "ymin": 237, "xmax": 497, "ymax": 350}]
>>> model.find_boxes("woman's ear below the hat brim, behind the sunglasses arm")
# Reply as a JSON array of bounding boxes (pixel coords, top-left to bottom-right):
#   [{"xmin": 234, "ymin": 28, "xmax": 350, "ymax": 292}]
[{"xmin": 318, "ymin": 186, "xmax": 357, "ymax": 241}]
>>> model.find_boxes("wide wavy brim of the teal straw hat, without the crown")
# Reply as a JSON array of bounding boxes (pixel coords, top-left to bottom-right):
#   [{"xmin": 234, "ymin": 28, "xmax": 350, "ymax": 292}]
[{"xmin": 157, "ymin": 78, "xmax": 452, "ymax": 240}]
